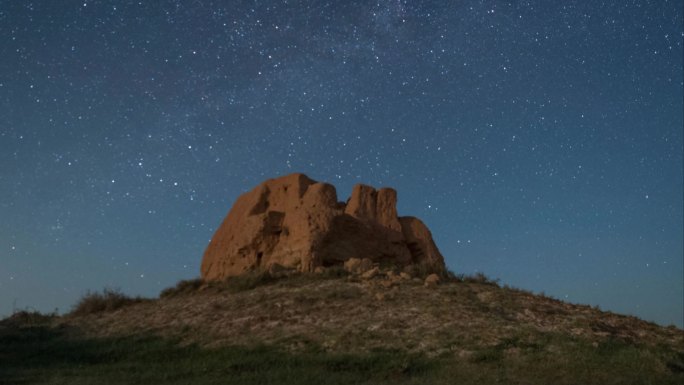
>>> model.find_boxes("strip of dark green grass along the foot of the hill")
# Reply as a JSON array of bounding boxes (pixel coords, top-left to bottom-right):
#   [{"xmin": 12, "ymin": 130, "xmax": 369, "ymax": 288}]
[{"xmin": 0, "ymin": 320, "xmax": 684, "ymax": 385}]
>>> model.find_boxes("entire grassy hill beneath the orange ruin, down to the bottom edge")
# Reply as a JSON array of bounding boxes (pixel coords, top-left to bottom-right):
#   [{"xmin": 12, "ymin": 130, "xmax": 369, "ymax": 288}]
[{"xmin": 0, "ymin": 267, "xmax": 684, "ymax": 384}]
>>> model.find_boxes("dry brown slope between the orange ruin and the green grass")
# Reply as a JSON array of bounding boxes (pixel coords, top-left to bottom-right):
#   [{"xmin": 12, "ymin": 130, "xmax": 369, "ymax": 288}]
[{"xmin": 61, "ymin": 273, "xmax": 684, "ymax": 355}]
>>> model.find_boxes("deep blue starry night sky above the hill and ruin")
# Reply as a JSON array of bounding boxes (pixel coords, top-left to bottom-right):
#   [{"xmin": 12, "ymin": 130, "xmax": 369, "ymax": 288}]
[{"xmin": 0, "ymin": 0, "xmax": 684, "ymax": 327}]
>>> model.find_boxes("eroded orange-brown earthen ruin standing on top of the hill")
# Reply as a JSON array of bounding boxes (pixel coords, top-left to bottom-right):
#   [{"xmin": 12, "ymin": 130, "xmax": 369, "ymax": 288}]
[{"xmin": 201, "ymin": 174, "xmax": 445, "ymax": 280}]
